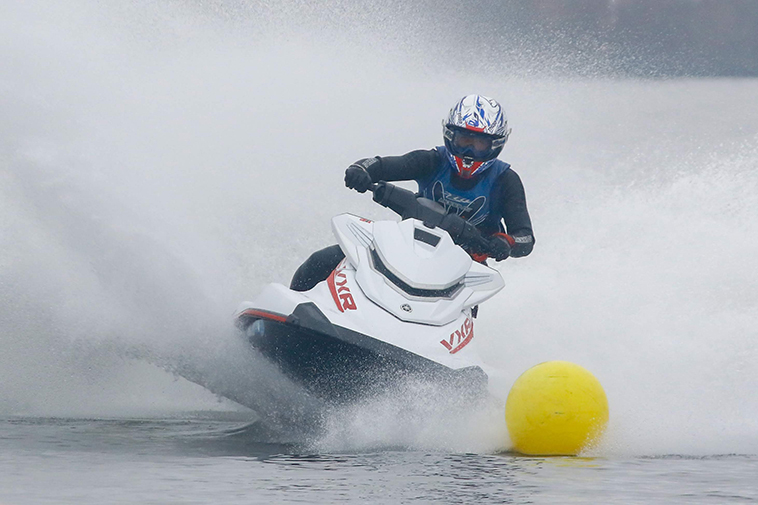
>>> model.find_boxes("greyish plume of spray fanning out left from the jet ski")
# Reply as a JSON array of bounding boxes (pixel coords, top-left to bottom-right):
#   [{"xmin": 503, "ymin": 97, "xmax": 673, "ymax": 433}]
[{"xmin": 0, "ymin": 160, "xmax": 328, "ymax": 435}]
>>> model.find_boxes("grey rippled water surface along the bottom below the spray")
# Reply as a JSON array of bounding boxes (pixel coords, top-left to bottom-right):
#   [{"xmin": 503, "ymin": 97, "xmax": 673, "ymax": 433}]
[{"xmin": 0, "ymin": 413, "xmax": 758, "ymax": 505}]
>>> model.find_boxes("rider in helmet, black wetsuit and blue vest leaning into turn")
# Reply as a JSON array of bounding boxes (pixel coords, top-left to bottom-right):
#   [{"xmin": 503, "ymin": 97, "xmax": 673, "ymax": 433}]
[{"xmin": 290, "ymin": 95, "xmax": 534, "ymax": 291}]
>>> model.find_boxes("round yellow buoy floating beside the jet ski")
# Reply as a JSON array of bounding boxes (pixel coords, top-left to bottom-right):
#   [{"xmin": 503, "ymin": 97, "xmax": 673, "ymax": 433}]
[{"xmin": 505, "ymin": 361, "xmax": 608, "ymax": 456}]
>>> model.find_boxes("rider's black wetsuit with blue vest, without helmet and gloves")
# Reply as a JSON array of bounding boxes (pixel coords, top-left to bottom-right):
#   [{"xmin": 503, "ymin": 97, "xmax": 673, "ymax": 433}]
[{"xmin": 290, "ymin": 147, "xmax": 534, "ymax": 291}]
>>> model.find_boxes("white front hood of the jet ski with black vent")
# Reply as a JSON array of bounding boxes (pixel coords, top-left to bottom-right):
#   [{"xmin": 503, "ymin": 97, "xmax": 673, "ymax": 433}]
[{"xmin": 327, "ymin": 214, "xmax": 503, "ymax": 326}]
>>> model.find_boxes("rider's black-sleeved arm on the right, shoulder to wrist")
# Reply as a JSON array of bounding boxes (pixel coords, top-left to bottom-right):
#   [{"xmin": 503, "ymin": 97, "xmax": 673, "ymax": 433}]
[{"xmin": 497, "ymin": 169, "xmax": 534, "ymax": 257}]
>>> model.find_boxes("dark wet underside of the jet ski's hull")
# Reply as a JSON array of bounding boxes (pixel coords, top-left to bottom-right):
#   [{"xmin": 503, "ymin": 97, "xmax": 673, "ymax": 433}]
[{"xmin": 238, "ymin": 303, "xmax": 487, "ymax": 404}]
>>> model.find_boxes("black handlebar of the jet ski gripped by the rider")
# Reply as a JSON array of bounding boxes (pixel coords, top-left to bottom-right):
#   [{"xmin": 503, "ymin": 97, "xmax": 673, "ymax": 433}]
[{"xmin": 369, "ymin": 181, "xmax": 491, "ymax": 254}]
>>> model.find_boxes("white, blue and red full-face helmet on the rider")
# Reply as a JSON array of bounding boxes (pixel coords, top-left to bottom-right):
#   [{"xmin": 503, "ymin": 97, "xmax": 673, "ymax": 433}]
[{"xmin": 442, "ymin": 95, "xmax": 511, "ymax": 179}]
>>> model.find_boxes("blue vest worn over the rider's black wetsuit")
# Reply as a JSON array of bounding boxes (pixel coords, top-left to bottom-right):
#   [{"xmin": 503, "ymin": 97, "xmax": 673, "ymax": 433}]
[{"xmin": 416, "ymin": 146, "xmax": 510, "ymax": 229}]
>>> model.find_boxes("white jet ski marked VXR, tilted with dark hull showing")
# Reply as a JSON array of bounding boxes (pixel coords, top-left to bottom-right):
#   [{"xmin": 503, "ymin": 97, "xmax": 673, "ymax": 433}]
[{"xmin": 236, "ymin": 182, "xmax": 504, "ymax": 404}]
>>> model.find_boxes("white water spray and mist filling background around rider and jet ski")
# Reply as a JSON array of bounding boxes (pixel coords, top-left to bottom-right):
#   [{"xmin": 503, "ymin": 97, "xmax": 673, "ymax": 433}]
[{"xmin": 0, "ymin": 1, "xmax": 758, "ymax": 454}]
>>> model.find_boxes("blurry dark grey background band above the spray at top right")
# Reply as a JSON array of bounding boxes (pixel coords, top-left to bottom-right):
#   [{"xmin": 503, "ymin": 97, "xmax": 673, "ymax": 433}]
[{"xmin": 446, "ymin": 0, "xmax": 758, "ymax": 78}]
